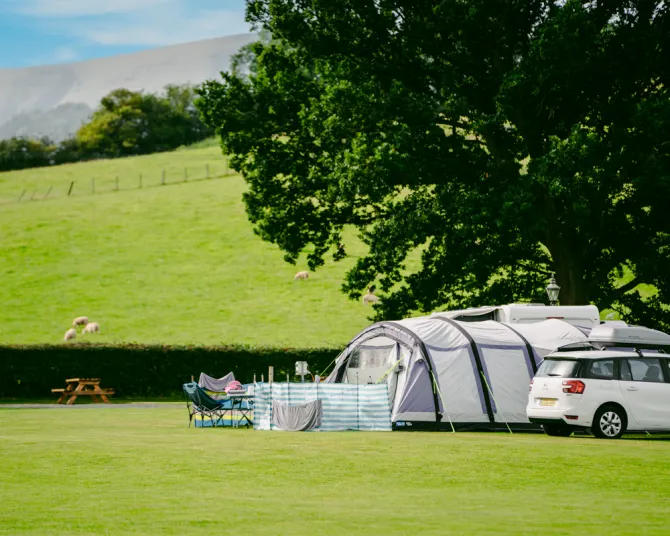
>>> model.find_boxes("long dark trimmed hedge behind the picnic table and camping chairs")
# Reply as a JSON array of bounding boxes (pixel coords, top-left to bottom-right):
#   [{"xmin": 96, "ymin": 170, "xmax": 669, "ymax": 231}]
[{"xmin": 0, "ymin": 344, "xmax": 339, "ymax": 399}]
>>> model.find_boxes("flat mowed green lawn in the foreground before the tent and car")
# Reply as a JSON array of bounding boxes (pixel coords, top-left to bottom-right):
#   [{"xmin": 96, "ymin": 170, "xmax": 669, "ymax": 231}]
[{"xmin": 0, "ymin": 404, "xmax": 670, "ymax": 535}]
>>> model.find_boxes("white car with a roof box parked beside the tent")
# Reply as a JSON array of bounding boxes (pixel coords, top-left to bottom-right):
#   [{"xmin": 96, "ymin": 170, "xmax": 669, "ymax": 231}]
[{"xmin": 526, "ymin": 324, "xmax": 670, "ymax": 439}]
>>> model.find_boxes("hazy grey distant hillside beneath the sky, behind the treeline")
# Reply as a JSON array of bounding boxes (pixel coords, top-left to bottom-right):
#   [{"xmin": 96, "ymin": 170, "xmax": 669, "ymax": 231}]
[{"xmin": 0, "ymin": 34, "xmax": 257, "ymax": 140}]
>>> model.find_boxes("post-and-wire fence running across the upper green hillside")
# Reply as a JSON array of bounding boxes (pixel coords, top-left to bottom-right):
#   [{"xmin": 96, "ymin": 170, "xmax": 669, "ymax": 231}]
[{"xmin": 0, "ymin": 162, "xmax": 236, "ymax": 205}]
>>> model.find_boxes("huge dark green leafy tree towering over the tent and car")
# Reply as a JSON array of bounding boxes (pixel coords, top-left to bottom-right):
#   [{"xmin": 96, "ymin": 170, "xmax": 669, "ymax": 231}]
[{"xmin": 198, "ymin": 0, "xmax": 670, "ymax": 328}]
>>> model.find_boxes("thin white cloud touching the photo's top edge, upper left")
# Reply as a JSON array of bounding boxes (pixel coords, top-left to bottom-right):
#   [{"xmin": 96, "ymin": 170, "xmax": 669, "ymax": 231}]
[{"xmin": 9, "ymin": 0, "xmax": 175, "ymax": 18}]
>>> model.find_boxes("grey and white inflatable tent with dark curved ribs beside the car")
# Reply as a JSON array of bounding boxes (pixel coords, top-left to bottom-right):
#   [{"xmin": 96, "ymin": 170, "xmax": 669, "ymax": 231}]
[{"xmin": 325, "ymin": 313, "xmax": 586, "ymax": 430}]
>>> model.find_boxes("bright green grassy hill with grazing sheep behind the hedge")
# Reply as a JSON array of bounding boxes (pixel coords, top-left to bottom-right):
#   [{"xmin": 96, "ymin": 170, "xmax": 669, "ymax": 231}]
[{"xmin": 0, "ymin": 144, "xmax": 371, "ymax": 346}]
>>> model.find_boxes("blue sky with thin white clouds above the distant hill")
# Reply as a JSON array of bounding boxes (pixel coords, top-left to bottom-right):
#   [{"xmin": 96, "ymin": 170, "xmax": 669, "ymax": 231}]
[{"xmin": 0, "ymin": 0, "xmax": 255, "ymax": 68}]
